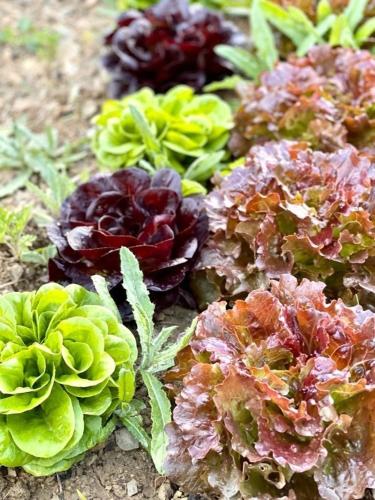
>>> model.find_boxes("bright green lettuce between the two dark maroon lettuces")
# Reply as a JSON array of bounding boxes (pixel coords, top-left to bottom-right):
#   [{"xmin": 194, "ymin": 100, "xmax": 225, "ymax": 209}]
[{"xmin": 92, "ymin": 85, "xmax": 233, "ymax": 181}]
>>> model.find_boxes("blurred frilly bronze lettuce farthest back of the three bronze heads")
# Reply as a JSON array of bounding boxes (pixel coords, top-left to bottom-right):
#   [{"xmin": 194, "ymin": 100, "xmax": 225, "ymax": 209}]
[{"xmin": 230, "ymin": 46, "xmax": 375, "ymax": 156}]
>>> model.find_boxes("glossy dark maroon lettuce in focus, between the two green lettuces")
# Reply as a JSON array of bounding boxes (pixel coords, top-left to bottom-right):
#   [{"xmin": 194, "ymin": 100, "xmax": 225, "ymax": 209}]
[{"xmin": 49, "ymin": 168, "xmax": 208, "ymax": 316}]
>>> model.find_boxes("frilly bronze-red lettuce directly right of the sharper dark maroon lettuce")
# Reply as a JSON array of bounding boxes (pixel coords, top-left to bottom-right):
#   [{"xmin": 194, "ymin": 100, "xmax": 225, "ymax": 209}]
[{"xmin": 192, "ymin": 141, "xmax": 375, "ymax": 305}]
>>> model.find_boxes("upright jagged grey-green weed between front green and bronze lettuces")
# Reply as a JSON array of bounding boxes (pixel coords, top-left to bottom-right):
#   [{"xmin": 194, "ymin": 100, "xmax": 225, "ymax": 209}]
[{"xmin": 120, "ymin": 248, "xmax": 195, "ymax": 473}]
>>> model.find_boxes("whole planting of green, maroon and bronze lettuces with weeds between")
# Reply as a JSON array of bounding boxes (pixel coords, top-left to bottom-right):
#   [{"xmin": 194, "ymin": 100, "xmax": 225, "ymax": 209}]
[{"xmin": 0, "ymin": 0, "xmax": 375, "ymax": 500}]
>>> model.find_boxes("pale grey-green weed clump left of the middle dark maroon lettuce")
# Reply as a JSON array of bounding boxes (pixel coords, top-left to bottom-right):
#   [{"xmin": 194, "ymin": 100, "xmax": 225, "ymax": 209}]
[{"xmin": 0, "ymin": 121, "xmax": 87, "ymax": 265}]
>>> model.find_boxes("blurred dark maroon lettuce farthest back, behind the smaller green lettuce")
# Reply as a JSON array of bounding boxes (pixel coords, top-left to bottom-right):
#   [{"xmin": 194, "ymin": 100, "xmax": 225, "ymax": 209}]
[{"xmin": 104, "ymin": 0, "xmax": 244, "ymax": 98}]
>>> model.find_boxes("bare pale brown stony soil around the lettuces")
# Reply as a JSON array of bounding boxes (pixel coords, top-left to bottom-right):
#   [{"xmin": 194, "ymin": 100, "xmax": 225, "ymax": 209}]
[{"xmin": 0, "ymin": 0, "xmax": 203, "ymax": 500}]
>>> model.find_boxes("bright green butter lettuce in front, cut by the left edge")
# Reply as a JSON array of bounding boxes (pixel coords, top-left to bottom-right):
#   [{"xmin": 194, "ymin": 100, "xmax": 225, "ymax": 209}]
[{"xmin": 0, "ymin": 283, "xmax": 137, "ymax": 475}]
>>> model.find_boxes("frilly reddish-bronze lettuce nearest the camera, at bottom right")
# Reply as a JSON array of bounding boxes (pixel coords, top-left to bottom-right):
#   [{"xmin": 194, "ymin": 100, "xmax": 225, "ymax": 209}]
[{"xmin": 166, "ymin": 275, "xmax": 375, "ymax": 500}]
